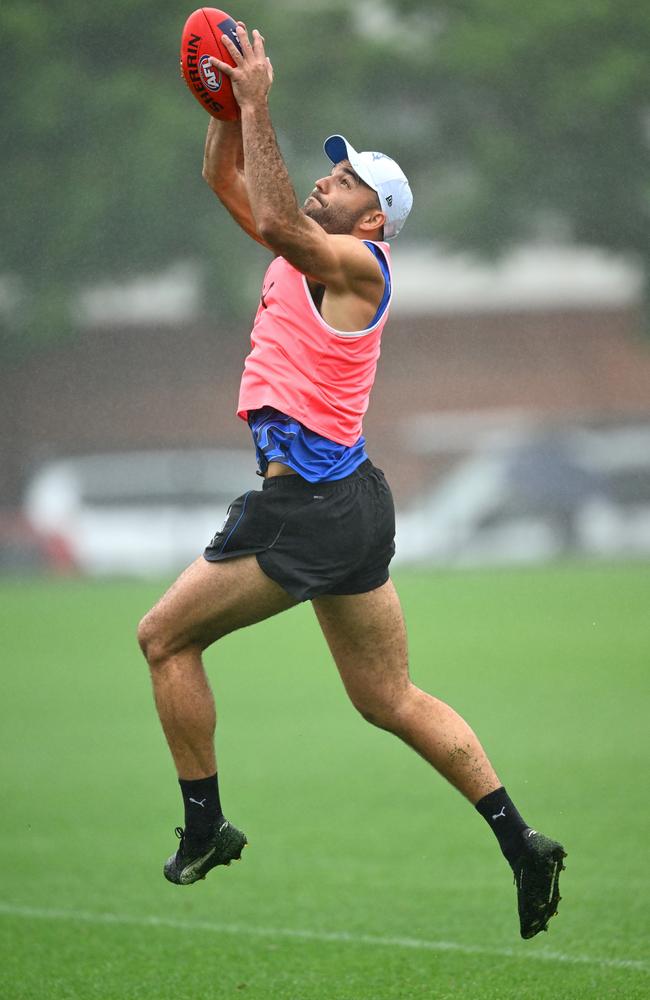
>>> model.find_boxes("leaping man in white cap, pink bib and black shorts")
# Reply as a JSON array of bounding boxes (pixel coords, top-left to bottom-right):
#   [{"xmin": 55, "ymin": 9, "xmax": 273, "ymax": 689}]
[{"xmin": 139, "ymin": 23, "xmax": 565, "ymax": 938}]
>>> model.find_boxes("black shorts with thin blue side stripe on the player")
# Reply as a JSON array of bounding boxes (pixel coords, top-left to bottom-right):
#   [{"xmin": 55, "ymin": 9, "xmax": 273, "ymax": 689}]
[{"xmin": 203, "ymin": 460, "xmax": 395, "ymax": 601}]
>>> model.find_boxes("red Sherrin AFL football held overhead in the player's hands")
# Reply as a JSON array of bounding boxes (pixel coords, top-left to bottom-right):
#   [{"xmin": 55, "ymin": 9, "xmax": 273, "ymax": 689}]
[{"xmin": 181, "ymin": 7, "xmax": 240, "ymax": 121}]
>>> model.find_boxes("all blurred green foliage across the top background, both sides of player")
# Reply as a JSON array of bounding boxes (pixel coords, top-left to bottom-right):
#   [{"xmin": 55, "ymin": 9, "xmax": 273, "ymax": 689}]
[{"xmin": 0, "ymin": 0, "xmax": 650, "ymax": 356}]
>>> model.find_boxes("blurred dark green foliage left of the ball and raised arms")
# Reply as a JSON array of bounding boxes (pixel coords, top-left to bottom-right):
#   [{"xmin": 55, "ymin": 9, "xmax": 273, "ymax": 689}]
[{"xmin": 0, "ymin": 0, "xmax": 260, "ymax": 360}]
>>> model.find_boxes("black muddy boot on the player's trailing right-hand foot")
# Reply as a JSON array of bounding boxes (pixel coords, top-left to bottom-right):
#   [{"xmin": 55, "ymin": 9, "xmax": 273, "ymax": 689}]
[{"xmin": 512, "ymin": 828, "xmax": 566, "ymax": 938}]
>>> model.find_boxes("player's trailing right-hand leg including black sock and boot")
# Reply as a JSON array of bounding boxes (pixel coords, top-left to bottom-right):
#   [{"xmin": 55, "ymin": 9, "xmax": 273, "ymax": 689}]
[{"xmin": 312, "ymin": 581, "xmax": 566, "ymax": 938}]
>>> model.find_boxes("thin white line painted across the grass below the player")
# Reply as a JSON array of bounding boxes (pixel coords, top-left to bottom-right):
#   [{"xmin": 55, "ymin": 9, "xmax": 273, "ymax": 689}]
[{"xmin": 0, "ymin": 902, "xmax": 650, "ymax": 972}]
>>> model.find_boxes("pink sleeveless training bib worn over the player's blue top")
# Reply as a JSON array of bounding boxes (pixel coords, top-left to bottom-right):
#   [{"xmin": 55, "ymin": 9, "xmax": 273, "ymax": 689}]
[{"xmin": 237, "ymin": 243, "xmax": 392, "ymax": 446}]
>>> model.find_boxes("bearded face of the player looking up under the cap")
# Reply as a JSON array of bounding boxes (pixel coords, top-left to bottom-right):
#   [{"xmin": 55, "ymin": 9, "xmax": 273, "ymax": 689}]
[{"xmin": 302, "ymin": 160, "xmax": 379, "ymax": 235}]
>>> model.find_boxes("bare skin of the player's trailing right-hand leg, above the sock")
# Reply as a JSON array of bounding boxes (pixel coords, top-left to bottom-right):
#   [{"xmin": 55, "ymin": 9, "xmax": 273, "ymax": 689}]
[{"xmin": 312, "ymin": 580, "xmax": 501, "ymax": 804}]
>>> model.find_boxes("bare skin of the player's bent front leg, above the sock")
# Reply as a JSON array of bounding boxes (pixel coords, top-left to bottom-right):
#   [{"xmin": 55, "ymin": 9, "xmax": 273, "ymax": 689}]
[{"xmin": 138, "ymin": 556, "xmax": 297, "ymax": 779}]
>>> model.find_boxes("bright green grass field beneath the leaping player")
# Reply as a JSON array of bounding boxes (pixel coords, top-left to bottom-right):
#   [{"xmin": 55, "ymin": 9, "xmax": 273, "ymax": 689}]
[{"xmin": 0, "ymin": 565, "xmax": 650, "ymax": 1000}]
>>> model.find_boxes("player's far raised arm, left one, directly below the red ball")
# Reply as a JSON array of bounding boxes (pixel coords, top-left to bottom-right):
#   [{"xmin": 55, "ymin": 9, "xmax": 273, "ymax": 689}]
[{"xmin": 203, "ymin": 118, "xmax": 268, "ymax": 246}]
